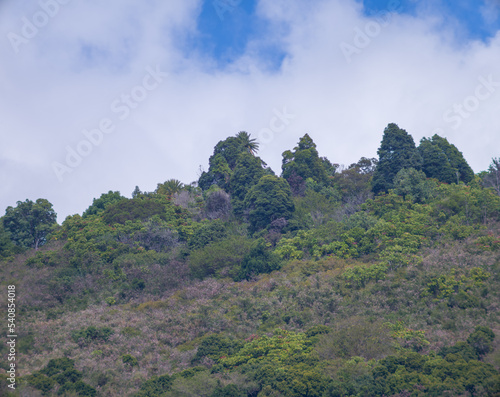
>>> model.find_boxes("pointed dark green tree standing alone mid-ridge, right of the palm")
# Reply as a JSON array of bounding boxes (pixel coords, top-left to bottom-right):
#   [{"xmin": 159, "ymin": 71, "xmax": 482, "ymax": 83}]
[{"xmin": 281, "ymin": 134, "xmax": 335, "ymax": 190}]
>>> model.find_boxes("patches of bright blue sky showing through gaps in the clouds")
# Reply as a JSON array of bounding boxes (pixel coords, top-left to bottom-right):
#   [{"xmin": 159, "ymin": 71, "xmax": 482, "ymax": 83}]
[{"xmin": 191, "ymin": 0, "xmax": 500, "ymax": 70}]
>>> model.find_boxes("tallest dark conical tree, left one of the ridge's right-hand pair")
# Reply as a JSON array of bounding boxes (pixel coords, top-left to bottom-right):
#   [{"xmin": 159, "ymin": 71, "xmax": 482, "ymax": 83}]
[{"xmin": 372, "ymin": 123, "xmax": 422, "ymax": 194}]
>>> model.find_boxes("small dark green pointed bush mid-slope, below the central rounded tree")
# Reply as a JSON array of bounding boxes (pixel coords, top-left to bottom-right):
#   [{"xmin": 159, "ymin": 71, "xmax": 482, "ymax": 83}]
[{"xmin": 239, "ymin": 238, "xmax": 281, "ymax": 279}]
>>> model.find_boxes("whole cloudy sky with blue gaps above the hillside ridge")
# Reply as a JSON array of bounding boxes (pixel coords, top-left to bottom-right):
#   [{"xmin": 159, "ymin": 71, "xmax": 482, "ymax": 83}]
[{"xmin": 0, "ymin": 0, "xmax": 500, "ymax": 222}]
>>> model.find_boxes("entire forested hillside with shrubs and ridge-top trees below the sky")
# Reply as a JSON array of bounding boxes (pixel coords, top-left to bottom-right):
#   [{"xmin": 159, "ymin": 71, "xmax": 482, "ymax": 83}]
[{"xmin": 0, "ymin": 124, "xmax": 500, "ymax": 397}]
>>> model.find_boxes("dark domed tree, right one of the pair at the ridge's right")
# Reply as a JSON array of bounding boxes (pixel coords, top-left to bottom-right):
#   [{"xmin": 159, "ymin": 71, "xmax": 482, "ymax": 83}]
[{"xmin": 418, "ymin": 135, "xmax": 474, "ymax": 184}]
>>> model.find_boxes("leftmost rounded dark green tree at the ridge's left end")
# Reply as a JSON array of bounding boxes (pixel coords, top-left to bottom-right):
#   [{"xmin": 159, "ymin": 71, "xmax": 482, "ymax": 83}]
[{"xmin": 3, "ymin": 199, "xmax": 57, "ymax": 249}]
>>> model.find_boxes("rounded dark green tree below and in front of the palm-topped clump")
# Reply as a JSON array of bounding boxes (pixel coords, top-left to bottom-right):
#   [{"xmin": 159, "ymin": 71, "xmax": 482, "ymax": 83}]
[{"xmin": 244, "ymin": 175, "xmax": 294, "ymax": 233}]
